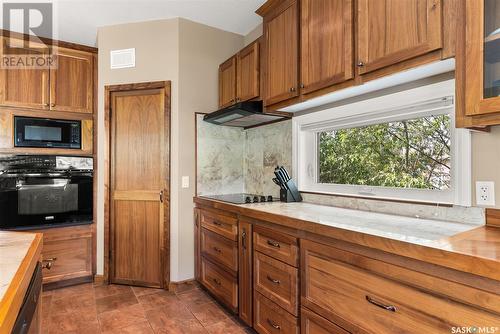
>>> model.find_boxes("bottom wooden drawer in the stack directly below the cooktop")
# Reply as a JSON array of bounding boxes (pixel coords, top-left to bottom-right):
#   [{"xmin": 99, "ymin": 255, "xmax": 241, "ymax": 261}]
[{"xmin": 201, "ymin": 257, "xmax": 238, "ymax": 312}]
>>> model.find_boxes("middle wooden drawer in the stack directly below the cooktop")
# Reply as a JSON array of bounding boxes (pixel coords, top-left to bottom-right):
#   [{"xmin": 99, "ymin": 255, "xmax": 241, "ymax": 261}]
[{"xmin": 201, "ymin": 228, "xmax": 238, "ymax": 273}]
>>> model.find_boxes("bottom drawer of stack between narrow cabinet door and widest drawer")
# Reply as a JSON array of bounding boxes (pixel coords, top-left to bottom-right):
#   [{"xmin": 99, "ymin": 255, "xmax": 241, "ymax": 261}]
[{"xmin": 254, "ymin": 292, "xmax": 299, "ymax": 334}]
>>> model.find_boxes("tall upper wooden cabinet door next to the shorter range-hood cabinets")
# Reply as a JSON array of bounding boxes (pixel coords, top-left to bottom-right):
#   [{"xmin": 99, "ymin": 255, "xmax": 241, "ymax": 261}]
[{"xmin": 264, "ymin": 1, "xmax": 299, "ymax": 105}]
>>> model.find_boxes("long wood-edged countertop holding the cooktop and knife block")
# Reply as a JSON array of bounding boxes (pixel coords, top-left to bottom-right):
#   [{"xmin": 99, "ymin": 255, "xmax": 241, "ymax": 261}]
[{"xmin": 194, "ymin": 196, "xmax": 500, "ymax": 280}]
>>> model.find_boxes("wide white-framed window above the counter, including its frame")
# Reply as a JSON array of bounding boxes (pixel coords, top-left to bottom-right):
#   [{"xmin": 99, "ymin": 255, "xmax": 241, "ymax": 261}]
[{"xmin": 294, "ymin": 80, "xmax": 470, "ymax": 205}]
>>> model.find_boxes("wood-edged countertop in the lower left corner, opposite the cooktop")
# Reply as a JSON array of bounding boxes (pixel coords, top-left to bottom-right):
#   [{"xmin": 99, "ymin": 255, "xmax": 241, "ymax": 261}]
[{"xmin": 0, "ymin": 231, "xmax": 42, "ymax": 332}]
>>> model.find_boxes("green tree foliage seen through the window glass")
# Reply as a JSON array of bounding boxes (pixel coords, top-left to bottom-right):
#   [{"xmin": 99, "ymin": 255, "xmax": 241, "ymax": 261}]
[{"xmin": 319, "ymin": 115, "xmax": 451, "ymax": 190}]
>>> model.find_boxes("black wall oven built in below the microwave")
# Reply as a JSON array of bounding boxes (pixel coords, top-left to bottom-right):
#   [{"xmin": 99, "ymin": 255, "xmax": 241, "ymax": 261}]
[{"xmin": 0, "ymin": 155, "xmax": 93, "ymax": 229}]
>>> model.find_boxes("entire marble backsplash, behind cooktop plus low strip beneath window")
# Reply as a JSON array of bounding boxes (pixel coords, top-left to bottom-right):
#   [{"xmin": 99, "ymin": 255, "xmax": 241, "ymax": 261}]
[{"xmin": 197, "ymin": 116, "xmax": 485, "ymax": 225}]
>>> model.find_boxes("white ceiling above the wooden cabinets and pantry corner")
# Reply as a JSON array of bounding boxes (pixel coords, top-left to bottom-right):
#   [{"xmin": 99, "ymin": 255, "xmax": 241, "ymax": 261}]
[{"xmin": 0, "ymin": 0, "xmax": 265, "ymax": 46}]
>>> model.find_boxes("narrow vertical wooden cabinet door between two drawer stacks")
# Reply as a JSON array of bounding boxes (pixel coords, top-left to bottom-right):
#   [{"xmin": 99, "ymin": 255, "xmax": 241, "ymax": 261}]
[{"xmin": 238, "ymin": 220, "xmax": 253, "ymax": 326}]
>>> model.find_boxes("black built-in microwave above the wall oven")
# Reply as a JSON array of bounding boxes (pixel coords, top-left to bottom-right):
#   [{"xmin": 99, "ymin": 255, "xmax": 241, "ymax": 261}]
[{"xmin": 14, "ymin": 116, "xmax": 82, "ymax": 149}]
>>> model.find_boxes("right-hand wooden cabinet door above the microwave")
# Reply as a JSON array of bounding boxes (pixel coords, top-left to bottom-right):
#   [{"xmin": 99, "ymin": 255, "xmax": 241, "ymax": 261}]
[{"xmin": 50, "ymin": 48, "xmax": 93, "ymax": 113}]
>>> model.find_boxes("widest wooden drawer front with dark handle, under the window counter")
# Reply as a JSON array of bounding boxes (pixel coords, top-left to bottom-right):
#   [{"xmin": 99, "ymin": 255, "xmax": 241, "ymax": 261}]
[{"xmin": 301, "ymin": 241, "xmax": 499, "ymax": 333}]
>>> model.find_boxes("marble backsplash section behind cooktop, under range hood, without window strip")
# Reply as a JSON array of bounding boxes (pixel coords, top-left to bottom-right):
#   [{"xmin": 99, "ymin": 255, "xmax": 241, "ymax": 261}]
[{"xmin": 196, "ymin": 115, "xmax": 292, "ymax": 197}]
